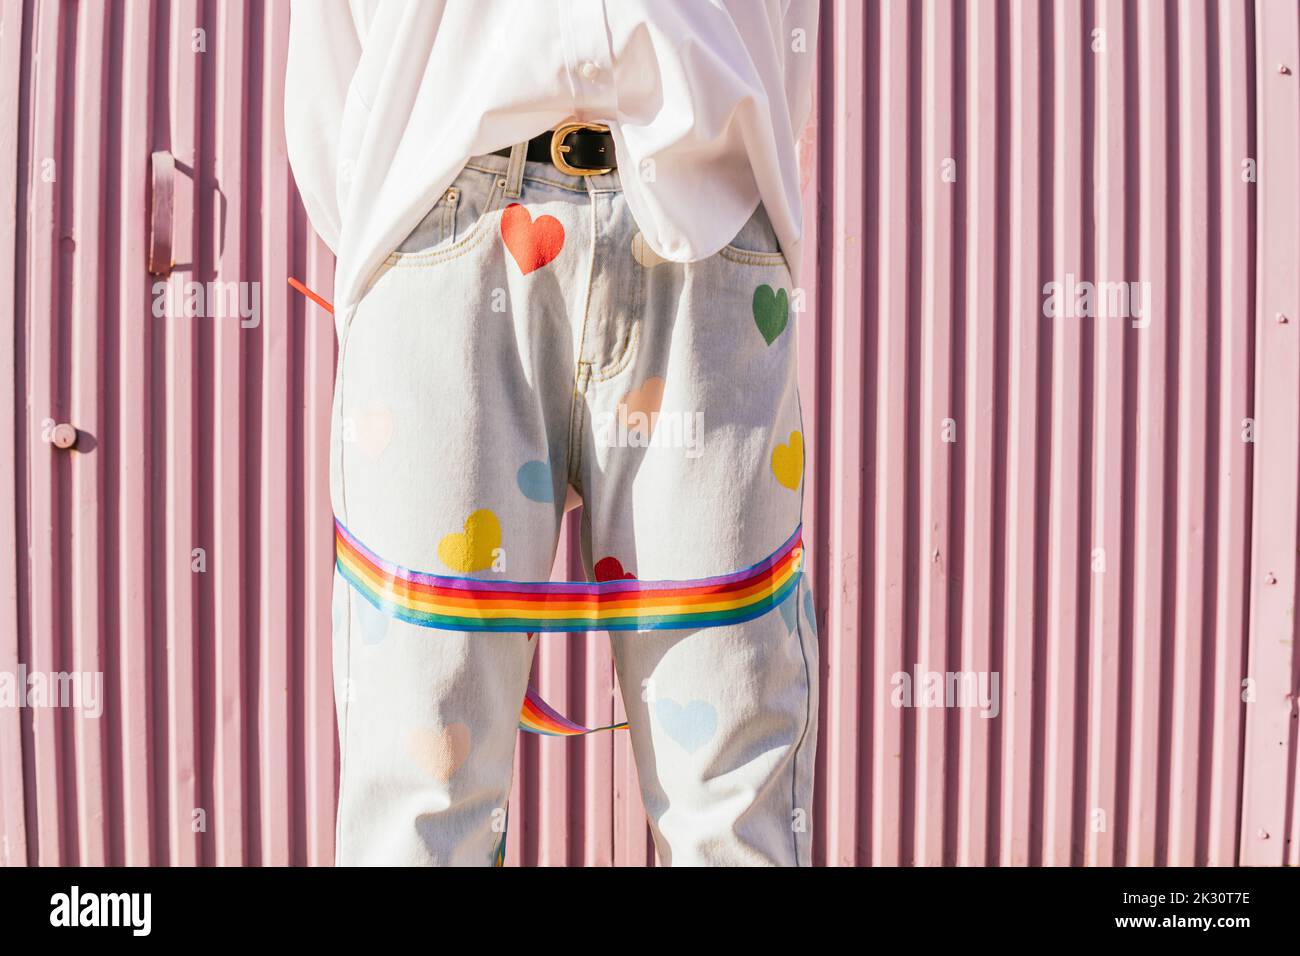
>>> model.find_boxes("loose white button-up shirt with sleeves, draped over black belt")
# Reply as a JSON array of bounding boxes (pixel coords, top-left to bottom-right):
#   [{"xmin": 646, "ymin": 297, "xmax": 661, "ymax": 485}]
[{"xmin": 285, "ymin": 0, "xmax": 818, "ymax": 310}]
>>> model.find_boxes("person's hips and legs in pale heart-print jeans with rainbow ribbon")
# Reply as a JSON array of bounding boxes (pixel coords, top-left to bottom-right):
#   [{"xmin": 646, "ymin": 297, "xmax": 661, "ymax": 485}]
[{"xmin": 332, "ymin": 140, "xmax": 818, "ymax": 865}]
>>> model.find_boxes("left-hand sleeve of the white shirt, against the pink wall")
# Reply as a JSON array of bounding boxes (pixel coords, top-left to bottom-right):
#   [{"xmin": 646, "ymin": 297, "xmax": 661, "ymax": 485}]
[{"xmin": 285, "ymin": 0, "xmax": 365, "ymax": 255}]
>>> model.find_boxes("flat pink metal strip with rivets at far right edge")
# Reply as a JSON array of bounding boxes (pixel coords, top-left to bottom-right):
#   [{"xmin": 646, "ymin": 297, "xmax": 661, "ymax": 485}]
[{"xmin": 1239, "ymin": 3, "xmax": 1300, "ymax": 866}]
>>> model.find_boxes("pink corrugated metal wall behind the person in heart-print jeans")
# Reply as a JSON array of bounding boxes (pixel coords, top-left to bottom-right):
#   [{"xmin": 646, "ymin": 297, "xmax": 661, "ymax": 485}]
[{"xmin": 0, "ymin": 0, "xmax": 1300, "ymax": 865}]
